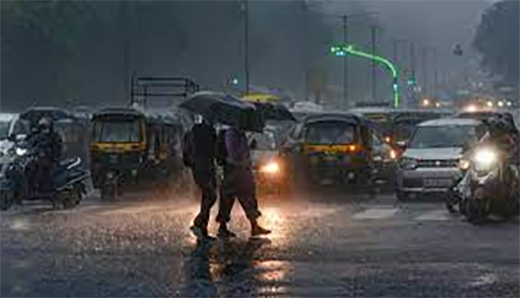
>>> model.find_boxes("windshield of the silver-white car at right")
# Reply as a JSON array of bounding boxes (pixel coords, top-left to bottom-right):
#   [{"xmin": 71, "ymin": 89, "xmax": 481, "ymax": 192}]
[{"xmin": 409, "ymin": 125, "xmax": 479, "ymax": 149}]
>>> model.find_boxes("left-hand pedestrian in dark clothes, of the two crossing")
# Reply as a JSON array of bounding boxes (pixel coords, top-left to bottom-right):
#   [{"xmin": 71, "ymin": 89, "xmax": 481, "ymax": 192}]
[{"xmin": 183, "ymin": 118, "xmax": 217, "ymax": 239}]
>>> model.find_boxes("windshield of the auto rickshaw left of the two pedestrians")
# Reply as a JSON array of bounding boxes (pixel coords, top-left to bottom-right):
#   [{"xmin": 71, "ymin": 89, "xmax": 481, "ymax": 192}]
[{"xmin": 92, "ymin": 120, "xmax": 141, "ymax": 143}]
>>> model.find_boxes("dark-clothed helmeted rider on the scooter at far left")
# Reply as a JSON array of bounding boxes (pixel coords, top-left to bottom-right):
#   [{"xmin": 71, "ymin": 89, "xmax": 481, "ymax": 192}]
[{"xmin": 28, "ymin": 117, "xmax": 62, "ymax": 195}]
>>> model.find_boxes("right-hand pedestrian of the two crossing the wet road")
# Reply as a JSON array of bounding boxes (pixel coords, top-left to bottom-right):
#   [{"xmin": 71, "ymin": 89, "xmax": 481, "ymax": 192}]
[{"xmin": 217, "ymin": 116, "xmax": 271, "ymax": 238}]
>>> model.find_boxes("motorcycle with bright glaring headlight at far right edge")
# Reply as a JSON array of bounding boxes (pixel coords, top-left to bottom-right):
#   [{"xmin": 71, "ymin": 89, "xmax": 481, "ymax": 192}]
[{"xmin": 453, "ymin": 146, "xmax": 520, "ymax": 223}]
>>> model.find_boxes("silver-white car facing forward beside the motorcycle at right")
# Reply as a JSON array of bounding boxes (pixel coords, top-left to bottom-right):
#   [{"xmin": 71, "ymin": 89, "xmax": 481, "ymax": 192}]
[{"xmin": 396, "ymin": 118, "xmax": 485, "ymax": 200}]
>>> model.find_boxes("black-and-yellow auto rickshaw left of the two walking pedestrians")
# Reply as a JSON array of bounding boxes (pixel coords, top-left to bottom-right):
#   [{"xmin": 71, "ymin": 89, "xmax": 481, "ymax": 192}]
[{"xmin": 90, "ymin": 108, "xmax": 183, "ymax": 199}]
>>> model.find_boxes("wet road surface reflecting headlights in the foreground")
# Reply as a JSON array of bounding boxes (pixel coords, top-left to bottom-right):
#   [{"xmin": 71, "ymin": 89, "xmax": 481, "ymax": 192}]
[{"xmin": 0, "ymin": 191, "xmax": 520, "ymax": 297}]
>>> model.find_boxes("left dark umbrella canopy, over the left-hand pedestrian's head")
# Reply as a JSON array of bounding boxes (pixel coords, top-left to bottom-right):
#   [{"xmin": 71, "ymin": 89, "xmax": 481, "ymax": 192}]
[{"xmin": 180, "ymin": 92, "xmax": 265, "ymax": 131}]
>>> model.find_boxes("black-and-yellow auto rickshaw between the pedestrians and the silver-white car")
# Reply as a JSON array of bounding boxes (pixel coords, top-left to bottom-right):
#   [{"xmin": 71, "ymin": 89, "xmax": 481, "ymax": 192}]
[{"xmin": 282, "ymin": 113, "xmax": 388, "ymax": 186}]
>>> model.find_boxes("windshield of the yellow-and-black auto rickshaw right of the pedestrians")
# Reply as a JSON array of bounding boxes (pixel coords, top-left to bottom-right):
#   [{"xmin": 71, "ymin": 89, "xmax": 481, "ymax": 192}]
[{"xmin": 305, "ymin": 121, "xmax": 356, "ymax": 145}]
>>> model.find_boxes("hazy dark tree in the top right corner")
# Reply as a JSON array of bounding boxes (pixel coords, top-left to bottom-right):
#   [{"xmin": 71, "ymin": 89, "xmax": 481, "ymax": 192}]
[{"xmin": 474, "ymin": 0, "xmax": 520, "ymax": 86}]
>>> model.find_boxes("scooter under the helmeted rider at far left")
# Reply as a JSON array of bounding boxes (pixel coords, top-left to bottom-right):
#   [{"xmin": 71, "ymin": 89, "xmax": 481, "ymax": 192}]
[{"xmin": 0, "ymin": 146, "xmax": 89, "ymax": 210}]
